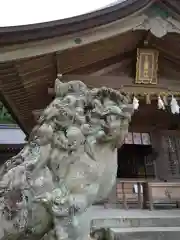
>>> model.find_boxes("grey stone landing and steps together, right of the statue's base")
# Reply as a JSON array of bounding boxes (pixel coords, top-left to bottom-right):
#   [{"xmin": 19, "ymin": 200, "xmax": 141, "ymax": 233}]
[{"xmin": 89, "ymin": 207, "xmax": 180, "ymax": 240}]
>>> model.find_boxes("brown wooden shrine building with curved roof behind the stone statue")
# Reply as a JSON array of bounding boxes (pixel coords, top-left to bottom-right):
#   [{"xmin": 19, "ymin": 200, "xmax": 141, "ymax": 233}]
[{"xmin": 0, "ymin": 0, "xmax": 180, "ymax": 209}]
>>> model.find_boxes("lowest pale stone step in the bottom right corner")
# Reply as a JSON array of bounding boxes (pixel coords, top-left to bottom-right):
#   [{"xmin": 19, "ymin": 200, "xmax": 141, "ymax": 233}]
[{"xmin": 107, "ymin": 227, "xmax": 180, "ymax": 240}]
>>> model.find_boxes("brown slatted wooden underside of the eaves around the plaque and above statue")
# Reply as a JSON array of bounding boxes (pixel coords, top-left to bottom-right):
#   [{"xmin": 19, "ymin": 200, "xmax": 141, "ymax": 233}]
[{"xmin": 0, "ymin": 31, "xmax": 180, "ymax": 133}]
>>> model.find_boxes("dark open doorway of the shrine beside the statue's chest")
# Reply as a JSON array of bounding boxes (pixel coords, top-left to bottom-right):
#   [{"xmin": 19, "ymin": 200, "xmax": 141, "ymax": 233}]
[{"xmin": 117, "ymin": 144, "xmax": 155, "ymax": 178}]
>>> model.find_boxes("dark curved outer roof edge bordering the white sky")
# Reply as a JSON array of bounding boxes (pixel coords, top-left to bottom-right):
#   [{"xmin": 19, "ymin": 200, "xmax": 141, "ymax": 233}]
[{"xmin": 0, "ymin": 0, "xmax": 153, "ymax": 45}]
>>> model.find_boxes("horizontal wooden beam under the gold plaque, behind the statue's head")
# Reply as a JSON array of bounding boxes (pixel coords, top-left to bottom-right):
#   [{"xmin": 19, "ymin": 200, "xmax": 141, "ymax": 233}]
[{"xmin": 48, "ymin": 75, "xmax": 180, "ymax": 95}]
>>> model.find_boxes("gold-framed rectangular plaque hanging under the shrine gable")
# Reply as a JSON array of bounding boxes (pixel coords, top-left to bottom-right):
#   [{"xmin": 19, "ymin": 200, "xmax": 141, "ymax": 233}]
[{"xmin": 136, "ymin": 48, "xmax": 159, "ymax": 84}]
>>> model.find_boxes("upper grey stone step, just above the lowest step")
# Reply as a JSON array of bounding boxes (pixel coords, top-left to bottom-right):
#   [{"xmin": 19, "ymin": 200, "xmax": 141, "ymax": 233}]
[{"xmin": 90, "ymin": 215, "xmax": 180, "ymax": 231}]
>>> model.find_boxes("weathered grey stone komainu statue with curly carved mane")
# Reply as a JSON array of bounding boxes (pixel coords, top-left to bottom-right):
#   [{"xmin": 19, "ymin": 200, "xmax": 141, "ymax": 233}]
[{"xmin": 0, "ymin": 79, "xmax": 133, "ymax": 240}]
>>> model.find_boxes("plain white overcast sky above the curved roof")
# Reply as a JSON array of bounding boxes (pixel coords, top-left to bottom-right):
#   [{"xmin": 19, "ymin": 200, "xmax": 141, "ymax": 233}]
[{"xmin": 0, "ymin": 0, "xmax": 125, "ymax": 27}]
